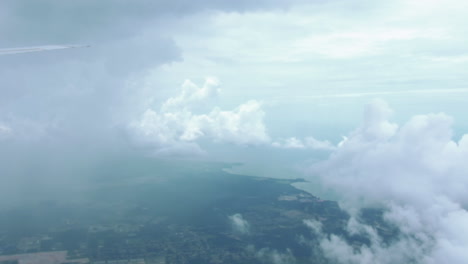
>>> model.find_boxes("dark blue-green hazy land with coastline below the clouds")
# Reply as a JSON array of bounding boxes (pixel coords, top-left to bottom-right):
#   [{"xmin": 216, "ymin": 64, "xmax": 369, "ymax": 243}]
[{"xmin": 0, "ymin": 158, "xmax": 392, "ymax": 263}]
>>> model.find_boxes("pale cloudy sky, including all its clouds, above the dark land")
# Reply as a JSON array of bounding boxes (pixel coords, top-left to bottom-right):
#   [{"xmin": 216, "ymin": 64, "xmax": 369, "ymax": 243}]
[{"xmin": 0, "ymin": 0, "xmax": 468, "ymax": 263}]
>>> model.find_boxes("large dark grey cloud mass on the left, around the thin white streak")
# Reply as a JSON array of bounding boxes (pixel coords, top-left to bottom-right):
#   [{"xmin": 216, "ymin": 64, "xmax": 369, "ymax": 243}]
[{"xmin": 0, "ymin": 0, "xmax": 308, "ymax": 204}]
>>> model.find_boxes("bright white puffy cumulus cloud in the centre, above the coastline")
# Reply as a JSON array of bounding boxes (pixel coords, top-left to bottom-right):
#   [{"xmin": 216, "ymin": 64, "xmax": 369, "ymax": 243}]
[{"xmin": 130, "ymin": 78, "xmax": 270, "ymax": 153}]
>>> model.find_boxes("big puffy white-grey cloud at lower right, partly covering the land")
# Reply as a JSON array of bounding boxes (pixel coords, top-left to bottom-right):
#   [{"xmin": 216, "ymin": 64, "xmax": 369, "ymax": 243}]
[{"xmin": 309, "ymin": 100, "xmax": 468, "ymax": 264}]
